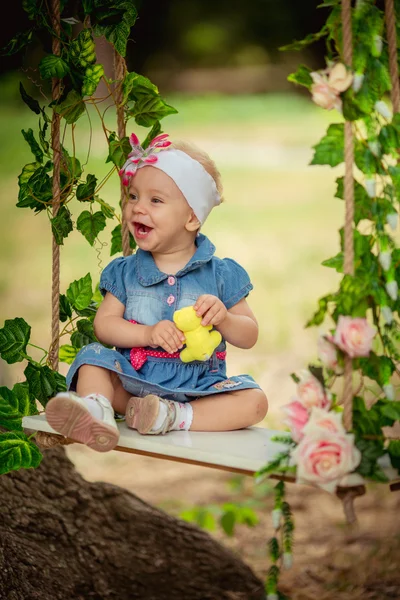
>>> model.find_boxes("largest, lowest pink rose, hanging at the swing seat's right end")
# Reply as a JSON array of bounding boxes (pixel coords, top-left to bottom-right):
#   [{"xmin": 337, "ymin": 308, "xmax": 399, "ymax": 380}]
[{"xmin": 292, "ymin": 427, "xmax": 361, "ymax": 493}]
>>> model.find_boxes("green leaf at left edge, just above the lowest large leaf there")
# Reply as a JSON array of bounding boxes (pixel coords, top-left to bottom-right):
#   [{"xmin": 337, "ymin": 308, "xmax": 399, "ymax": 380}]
[{"xmin": 0, "ymin": 382, "xmax": 38, "ymax": 431}]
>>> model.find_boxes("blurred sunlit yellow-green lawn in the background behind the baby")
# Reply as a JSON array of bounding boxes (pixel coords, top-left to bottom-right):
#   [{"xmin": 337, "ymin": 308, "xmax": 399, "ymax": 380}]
[{"xmin": 0, "ymin": 95, "xmax": 343, "ymax": 414}]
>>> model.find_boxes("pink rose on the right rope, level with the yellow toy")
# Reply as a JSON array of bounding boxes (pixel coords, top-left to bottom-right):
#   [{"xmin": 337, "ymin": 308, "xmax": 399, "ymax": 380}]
[{"xmin": 333, "ymin": 315, "xmax": 376, "ymax": 358}]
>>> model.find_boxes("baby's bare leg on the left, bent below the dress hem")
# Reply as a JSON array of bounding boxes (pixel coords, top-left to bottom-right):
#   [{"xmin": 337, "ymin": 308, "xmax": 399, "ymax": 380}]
[{"xmin": 76, "ymin": 365, "xmax": 132, "ymax": 414}]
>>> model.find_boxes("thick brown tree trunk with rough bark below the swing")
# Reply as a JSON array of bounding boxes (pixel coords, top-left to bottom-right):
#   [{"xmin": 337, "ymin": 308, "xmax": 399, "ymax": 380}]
[{"xmin": 0, "ymin": 447, "xmax": 265, "ymax": 600}]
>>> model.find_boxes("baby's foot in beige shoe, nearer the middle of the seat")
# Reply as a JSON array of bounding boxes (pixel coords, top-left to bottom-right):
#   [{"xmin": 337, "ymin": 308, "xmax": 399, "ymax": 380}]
[{"xmin": 125, "ymin": 394, "xmax": 176, "ymax": 435}]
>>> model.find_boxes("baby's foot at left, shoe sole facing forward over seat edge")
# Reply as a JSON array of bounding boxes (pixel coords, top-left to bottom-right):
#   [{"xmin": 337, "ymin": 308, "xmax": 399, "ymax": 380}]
[{"xmin": 46, "ymin": 392, "xmax": 119, "ymax": 452}]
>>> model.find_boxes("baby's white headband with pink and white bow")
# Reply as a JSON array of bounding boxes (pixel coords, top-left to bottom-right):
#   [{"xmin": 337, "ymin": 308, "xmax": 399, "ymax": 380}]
[{"xmin": 120, "ymin": 134, "xmax": 221, "ymax": 224}]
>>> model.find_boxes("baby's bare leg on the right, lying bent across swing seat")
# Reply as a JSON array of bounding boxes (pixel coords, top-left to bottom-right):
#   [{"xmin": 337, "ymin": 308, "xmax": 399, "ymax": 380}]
[{"xmin": 190, "ymin": 388, "xmax": 268, "ymax": 431}]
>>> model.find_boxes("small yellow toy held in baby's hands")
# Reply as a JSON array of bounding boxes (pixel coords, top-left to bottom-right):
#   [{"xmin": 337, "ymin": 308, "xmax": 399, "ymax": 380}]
[{"xmin": 173, "ymin": 306, "xmax": 222, "ymax": 362}]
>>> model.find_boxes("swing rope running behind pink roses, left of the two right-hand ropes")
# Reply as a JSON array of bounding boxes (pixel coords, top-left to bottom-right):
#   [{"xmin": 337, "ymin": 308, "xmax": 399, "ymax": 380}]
[{"xmin": 342, "ymin": 0, "xmax": 354, "ymax": 431}]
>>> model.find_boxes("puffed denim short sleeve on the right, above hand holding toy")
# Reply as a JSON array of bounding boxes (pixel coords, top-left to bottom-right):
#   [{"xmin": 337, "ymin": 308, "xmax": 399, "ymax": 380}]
[{"xmin": 217, "ymin": 258, "xmax": 253, "ymax": 309}]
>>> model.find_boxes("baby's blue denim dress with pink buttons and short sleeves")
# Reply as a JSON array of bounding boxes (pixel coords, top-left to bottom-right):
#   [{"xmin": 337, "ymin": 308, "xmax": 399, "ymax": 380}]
[{"xmin": 67, "ymin": 234, "xmax": 260, "ymax": 402}]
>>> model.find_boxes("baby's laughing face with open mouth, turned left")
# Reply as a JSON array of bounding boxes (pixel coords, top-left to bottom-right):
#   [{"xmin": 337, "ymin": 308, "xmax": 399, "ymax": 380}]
[{"xmin": 125, "ymin": 166, "xmax": 200, "ymax": 253}]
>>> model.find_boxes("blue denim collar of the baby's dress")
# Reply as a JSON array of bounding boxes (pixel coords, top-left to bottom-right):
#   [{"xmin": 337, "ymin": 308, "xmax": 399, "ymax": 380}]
[{"xmin": 136, "ymin": 233, "xmax": 215, "ymax": 286}]
